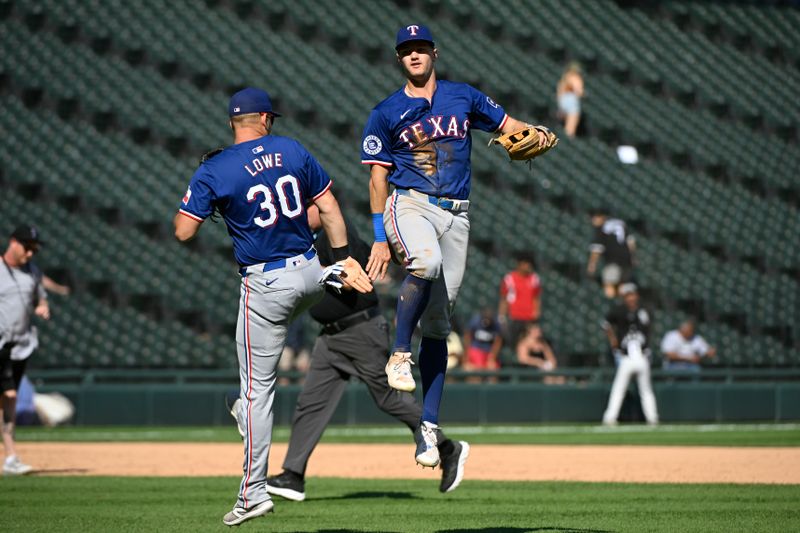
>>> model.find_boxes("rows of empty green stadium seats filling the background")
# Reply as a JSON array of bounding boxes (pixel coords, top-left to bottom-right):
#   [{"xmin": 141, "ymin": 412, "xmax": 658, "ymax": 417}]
[{"xmin": 0, "ymin": 0, "xmax": 800, "ymax": 367}]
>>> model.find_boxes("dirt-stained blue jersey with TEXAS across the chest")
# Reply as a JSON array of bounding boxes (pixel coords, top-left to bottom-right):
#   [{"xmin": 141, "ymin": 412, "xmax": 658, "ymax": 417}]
[{"xmin": 361, "ymin": 80, "xmax": 508, "ymax": 200}]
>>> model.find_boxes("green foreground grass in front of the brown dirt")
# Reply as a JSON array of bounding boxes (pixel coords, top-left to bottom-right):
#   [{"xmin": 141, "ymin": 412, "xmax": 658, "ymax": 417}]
[{"xmin": 0, "ymin": 477, "xmax": 800, "ymax": 533}]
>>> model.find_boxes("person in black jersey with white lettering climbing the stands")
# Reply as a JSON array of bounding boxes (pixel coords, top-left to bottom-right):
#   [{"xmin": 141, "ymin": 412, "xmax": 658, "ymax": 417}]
[{"xmin": 586, "ymin": 208, "xmax": 636, "ymax": 299}]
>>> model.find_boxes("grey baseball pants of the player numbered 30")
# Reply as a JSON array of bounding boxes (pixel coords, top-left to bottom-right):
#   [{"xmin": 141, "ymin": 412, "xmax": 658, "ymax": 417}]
[{"xmin": 236, "ymin": 251, "xmax": 322, "ymax": 508}]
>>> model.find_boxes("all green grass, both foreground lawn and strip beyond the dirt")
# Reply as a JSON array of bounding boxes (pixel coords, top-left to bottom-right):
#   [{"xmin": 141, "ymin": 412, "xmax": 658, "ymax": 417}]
[{"xmin": 6, "ymin": 424, "xmax": 800, "ymax": 533}]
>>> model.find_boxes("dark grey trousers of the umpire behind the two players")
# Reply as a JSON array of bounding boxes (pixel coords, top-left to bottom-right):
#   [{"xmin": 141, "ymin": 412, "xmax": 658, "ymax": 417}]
[{"xmin": 283, "ymin": 316, "xmax": 422, "ymax": 475}]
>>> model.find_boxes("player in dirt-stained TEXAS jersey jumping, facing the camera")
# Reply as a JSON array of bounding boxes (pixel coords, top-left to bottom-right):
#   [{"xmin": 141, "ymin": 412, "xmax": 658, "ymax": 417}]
[{"xmin": 361, "ymin": 24, "xmax": 546, "ymax": 467}]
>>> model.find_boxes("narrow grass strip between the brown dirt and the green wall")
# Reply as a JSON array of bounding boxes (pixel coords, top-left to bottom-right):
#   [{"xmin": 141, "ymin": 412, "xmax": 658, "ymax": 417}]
[{"xmin": 17, "ymin": 424, "xmax": 800, "ymax": 446}]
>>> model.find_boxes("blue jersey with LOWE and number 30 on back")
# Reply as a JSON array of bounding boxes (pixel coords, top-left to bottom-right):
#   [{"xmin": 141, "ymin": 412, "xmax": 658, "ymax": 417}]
[{"xmin": 180, "ymin": 135, "xmax": 331, "ymax": 266}]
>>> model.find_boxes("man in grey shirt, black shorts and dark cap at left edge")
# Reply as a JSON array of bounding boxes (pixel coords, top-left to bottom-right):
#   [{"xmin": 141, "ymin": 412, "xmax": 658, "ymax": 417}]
[{"xmin": 0, "ymin": 226, "xmax": 50, "ymax": 475}]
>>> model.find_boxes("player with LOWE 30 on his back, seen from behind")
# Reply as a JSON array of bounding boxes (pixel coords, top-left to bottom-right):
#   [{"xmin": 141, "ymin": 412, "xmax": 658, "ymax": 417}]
[{"xmin": 174, "ymin": 87, "xmax": 372, "ymax": 526}]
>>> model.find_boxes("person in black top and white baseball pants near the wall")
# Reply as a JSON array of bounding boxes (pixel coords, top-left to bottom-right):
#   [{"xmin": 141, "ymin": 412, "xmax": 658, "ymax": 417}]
[{"xmin": 603, "ymin": 283, "xmax": 658, "ymax": 425}]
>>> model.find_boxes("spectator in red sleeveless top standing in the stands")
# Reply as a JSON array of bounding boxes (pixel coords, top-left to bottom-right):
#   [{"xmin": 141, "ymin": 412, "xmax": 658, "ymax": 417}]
[{"xmin": 497, "ymin": 254, "xmax": 542, "ymax": 350}]
